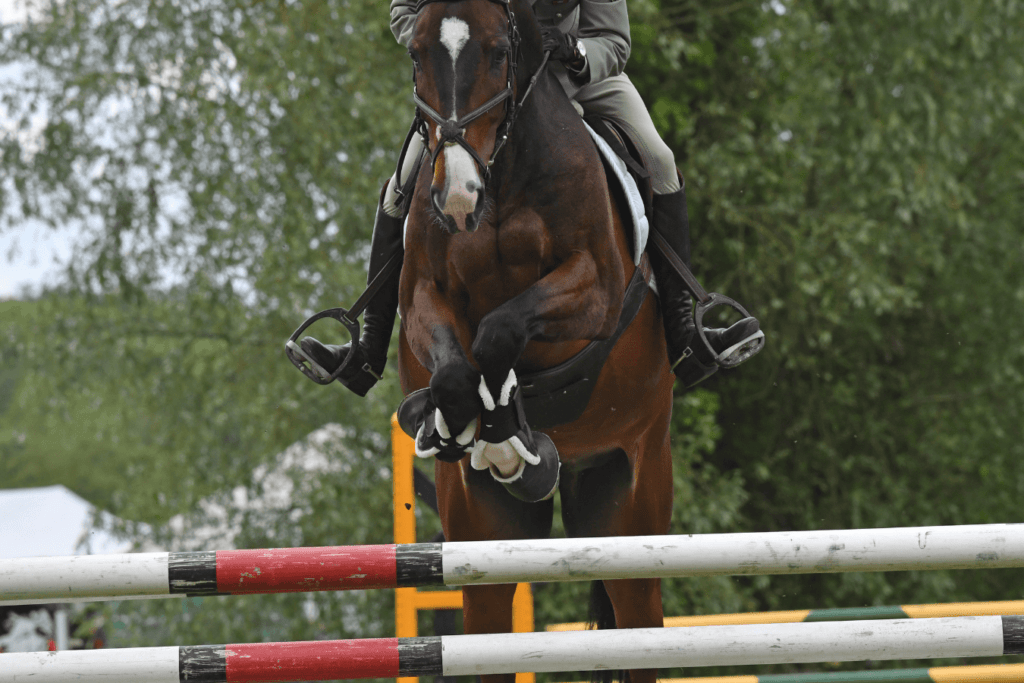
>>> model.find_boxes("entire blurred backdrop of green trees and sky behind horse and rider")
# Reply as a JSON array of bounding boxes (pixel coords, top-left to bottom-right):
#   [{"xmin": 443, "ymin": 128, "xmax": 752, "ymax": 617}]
[{"xmin": 0, "ymin": 0, "xmax": 1024, "ymax": 680}]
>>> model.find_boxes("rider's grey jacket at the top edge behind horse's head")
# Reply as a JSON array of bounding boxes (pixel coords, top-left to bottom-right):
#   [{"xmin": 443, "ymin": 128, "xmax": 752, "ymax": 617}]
[{"xmin": 391, "ymin": 0, "xmax": 630, "ymax": 97}]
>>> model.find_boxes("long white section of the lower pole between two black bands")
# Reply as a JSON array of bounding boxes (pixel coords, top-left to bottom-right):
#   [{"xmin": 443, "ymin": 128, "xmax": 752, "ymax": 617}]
[{"xmin": 441, "ymin": 616, "xmax": 1002, "ymax": 676}]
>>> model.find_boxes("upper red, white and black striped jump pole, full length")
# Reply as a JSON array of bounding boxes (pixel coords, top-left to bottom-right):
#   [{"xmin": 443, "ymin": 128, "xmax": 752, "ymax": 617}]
[{"xmin": 0, "ymin": 524, "xmax": 1024, "ymax": 606}]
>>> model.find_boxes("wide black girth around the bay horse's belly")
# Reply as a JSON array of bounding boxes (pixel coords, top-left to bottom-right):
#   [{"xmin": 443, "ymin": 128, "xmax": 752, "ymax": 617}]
[{"xmin": 516, "ymin": 254, "xmax": 651, "ymax": 429}]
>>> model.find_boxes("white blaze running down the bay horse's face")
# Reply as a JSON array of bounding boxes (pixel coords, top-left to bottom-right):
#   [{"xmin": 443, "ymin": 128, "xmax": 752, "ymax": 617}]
[{"xmin": 437, "ymin": 16, "xmax": 483, "ymax": 230}]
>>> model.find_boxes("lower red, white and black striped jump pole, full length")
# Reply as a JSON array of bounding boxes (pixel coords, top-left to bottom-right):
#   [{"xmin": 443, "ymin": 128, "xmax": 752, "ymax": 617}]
[{"xmin": 0, "ymin": 616, "xmax": 1024, "ymax": 683}]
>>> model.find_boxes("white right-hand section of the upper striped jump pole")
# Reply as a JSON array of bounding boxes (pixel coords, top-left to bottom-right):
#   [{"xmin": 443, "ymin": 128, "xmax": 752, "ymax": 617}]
[{"xmin": 441, "ymin": 524, "xmax": 1024, "ymax": 586}]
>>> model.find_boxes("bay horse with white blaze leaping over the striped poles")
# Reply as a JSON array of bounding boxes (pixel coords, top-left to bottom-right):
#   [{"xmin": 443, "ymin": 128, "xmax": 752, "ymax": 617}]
[{"xmin": 398, "ymin": 0, "xmax": 674, "ymax": 683}]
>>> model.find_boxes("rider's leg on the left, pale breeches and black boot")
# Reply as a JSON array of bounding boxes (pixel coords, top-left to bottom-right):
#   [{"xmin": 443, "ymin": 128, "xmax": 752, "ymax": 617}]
[{"xmin": 301, "ymin": 132, "xmax": 423, "ymax": 396}]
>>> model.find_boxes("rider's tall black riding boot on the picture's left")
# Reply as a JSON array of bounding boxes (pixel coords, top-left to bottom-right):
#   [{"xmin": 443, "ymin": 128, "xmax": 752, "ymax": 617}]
[{"xmin": 301, "ymin": 184, "xmax": 406, "ymax": 396}]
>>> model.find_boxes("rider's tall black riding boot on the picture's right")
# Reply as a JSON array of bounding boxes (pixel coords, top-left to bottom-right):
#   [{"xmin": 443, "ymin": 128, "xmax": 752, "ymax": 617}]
[{"xmin": 647, "ymin": 186, "xmax": 760, "ymax": 387}]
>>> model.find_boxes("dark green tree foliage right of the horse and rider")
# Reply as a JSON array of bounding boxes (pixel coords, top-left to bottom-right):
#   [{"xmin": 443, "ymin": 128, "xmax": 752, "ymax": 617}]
[{"xmin": 633, "ymin": 0, "xmax": 1024, "ymax": 626}]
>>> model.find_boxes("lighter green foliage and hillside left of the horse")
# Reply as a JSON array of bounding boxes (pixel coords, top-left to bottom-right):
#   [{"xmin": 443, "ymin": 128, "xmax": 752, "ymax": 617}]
[{"xmin": 0, "ymin": 0, "xmax": 411, "ymax": 659}]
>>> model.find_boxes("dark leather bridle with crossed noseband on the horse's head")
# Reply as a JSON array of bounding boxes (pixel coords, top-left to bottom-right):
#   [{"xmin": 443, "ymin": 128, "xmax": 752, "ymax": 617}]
[{"xmin": 413, "ymin": 0, "xmax": 551, "ymax": 183}]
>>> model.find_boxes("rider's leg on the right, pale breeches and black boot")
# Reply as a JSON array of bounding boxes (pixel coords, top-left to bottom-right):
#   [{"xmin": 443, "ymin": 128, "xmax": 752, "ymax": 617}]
[{"xmin": 575, "ymin": 74, "xmax": 759, "ymax": 386}]
